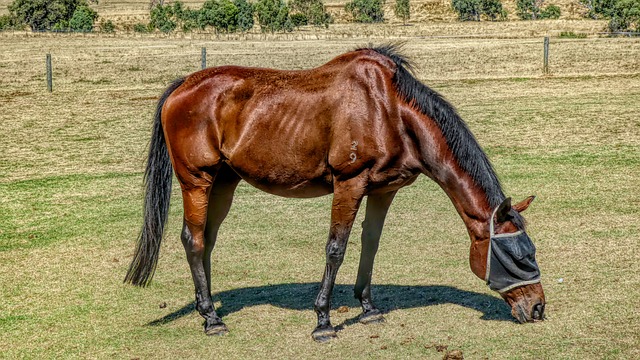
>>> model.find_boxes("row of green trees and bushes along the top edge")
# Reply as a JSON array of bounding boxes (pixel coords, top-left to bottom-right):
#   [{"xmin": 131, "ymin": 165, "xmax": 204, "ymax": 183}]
[{"xmin": 0, "ymin": 0, "xmax": 640, "ymax": 33}]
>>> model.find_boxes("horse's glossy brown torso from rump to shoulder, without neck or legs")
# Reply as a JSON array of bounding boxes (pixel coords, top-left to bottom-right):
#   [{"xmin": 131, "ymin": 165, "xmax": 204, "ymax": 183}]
[{"xmin": 163, "ymin": 52, "xmax": 418, "ymax": 197}]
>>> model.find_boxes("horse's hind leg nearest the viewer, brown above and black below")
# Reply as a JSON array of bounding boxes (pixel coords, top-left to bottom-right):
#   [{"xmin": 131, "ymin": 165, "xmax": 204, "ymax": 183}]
[{"xmin": 181, "ymin": 173, "xmax": 228, "ymax": 335}]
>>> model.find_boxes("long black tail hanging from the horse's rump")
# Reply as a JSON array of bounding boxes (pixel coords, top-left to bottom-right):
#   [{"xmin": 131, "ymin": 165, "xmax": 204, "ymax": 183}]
[{"xmin": 124, "ymin": 79, "xmax": 184, "ymax": 286}]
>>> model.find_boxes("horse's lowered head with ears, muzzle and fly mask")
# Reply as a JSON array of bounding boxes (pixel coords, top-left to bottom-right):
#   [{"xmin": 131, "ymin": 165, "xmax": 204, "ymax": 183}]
[{"xmin": 470, "ymin": 196, "xmax": 545, "ymax": 323}]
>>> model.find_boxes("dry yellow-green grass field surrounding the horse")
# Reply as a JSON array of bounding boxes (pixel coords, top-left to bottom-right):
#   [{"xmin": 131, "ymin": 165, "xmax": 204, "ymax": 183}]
[{"xmin": 0, "ymin": 25, "xmax": 640, "ymax": 359}]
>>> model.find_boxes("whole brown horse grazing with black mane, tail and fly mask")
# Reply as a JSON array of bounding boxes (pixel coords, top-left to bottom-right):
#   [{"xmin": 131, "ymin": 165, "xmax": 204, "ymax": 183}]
[{"xmin": 125, "ymin": 45, "xmax": 545, "ymax": 341}]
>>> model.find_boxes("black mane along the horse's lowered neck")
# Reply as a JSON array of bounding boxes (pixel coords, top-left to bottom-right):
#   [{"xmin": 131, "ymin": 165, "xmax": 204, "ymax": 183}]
[{"xmin": 367, "ymin": 45, "xmax": 522, "ymax": 225}]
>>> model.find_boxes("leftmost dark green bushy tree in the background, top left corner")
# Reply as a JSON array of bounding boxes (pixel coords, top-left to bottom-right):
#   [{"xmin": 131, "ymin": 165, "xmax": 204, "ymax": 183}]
[{"xmin": 9, "ymin": 0, "xmax": 95, "ymax": 31}]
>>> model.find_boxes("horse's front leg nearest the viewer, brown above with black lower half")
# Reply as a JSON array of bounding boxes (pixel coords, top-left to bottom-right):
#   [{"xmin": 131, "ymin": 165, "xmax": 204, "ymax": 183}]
[{"xmin": 311, "ymin": 179, "xmax": 364, "ymax": 341}]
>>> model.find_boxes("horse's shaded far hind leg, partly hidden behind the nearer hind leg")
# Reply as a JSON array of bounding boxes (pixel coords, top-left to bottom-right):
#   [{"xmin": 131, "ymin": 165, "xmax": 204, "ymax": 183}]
[{"xmin": 203, "ymin": 165, "xmax": 240, "ymax": 298}]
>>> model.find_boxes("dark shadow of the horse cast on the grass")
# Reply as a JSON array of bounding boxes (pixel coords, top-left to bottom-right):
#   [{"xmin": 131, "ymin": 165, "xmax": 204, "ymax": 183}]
[{"xmin": 148, "ymin": 283, "xmax": 513, "ymax": 326}]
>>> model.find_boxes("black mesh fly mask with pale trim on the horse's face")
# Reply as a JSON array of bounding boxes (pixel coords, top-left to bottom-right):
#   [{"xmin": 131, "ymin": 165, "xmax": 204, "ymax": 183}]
[{"xmin": 485, "ymin": 205, "xmax": 540, "ymax": 293}]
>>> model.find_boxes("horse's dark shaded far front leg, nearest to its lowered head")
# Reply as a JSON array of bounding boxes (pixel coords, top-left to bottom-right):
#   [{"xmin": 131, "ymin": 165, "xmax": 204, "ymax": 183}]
[{"xmin": 354, "ymin": 191, "xmax": 396, "ymax": 324}]
